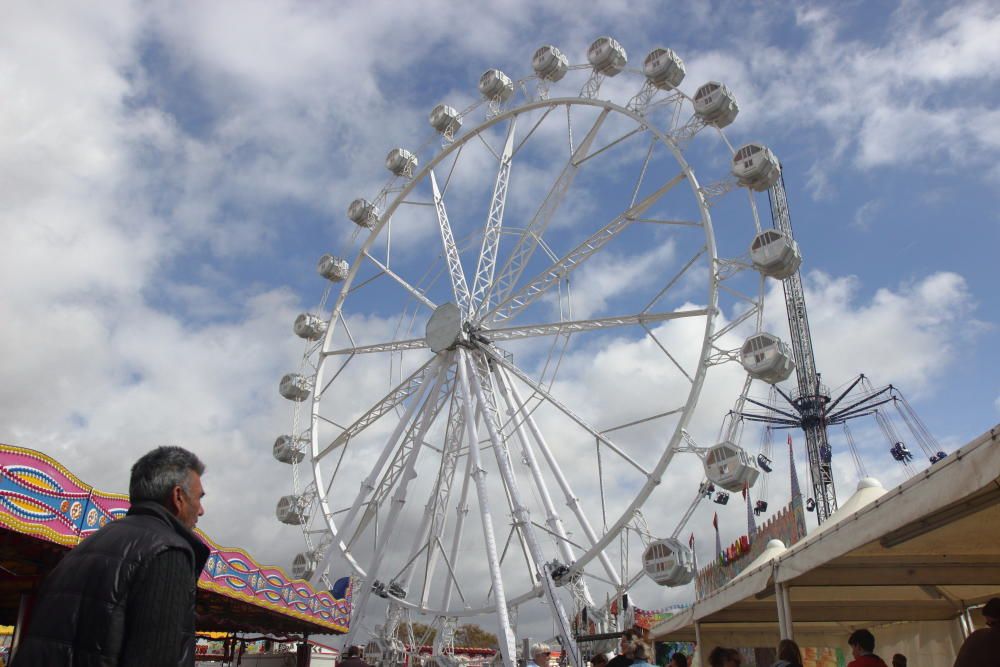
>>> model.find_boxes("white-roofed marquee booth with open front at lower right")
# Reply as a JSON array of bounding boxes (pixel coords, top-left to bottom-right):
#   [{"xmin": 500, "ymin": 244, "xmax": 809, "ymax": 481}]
[{"xmin": 652, "ymin": 424, "xmax": 1000, "ymax": 667}]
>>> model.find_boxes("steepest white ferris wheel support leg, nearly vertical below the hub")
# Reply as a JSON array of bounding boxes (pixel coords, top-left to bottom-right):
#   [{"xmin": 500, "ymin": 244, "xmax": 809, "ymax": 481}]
[{"xmin": 458, "ymin": 348, "xmax": 516, "ymax": 667}]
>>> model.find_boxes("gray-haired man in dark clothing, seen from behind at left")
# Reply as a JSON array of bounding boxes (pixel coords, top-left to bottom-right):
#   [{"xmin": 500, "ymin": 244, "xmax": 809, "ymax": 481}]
[{"xmin": 11, "ymin": 447, "xmax": 209, "ymax": 667}]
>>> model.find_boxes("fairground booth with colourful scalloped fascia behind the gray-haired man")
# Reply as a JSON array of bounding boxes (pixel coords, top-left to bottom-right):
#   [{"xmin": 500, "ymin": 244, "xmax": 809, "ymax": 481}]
[{"xmin": 0, "ymin": 445, "xmax": 351, "ymax": 665}]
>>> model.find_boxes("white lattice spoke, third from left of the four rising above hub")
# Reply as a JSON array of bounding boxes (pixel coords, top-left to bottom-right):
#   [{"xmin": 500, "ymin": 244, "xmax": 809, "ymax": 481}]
[{"xmin": 483, "ymin": 107, "xmax": 611, "ymax": 310}]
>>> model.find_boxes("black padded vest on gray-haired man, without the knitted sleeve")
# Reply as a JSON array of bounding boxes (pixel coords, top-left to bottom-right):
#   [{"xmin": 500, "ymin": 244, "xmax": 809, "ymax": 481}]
[{"xmin": 11, "ymin": 502, "xmax": 209, "ymax": 667}]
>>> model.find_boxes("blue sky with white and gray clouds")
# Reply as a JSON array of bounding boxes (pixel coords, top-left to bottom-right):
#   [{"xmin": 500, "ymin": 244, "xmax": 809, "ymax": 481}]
[{"xmin": 0, "ymin": 0, "xmax": 1000, "ymax": 648}]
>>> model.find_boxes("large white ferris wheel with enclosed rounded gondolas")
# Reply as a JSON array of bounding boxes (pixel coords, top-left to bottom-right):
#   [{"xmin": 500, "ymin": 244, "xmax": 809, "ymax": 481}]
[{"xmin": 274, "ymin": 37, "xmax": 780, "ymax": 664}]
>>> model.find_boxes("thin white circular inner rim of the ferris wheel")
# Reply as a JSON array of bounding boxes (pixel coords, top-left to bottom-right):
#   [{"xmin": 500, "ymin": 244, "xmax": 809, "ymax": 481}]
[{"xmin": 300, "ymin": 91, "xmax": 724, "ymax": 617}]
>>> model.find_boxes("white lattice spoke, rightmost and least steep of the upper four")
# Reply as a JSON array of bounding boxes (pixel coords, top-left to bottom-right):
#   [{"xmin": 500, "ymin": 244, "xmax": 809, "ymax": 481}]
[{"xmin": 481, "ymin": 172, "xmax": 687, "ymax": 322}]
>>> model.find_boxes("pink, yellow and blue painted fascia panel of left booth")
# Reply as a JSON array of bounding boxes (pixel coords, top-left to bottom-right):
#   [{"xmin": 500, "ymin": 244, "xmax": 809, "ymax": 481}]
[{"xmin": 0, "ymin": 445, "xmax": 352, "ymax": 632}]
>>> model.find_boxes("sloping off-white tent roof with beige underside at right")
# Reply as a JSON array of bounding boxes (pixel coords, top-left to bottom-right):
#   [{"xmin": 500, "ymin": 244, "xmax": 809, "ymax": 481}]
[{"xmin": 653, "ymin": 425, "xmax": 1000, "ymax": 645}]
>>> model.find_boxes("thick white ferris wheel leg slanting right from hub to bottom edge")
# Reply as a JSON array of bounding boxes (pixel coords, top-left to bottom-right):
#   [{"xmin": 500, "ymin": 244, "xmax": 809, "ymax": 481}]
[{"xmin": 470, "ymin": 352, "xmax": 580, "ymax": 665}]
